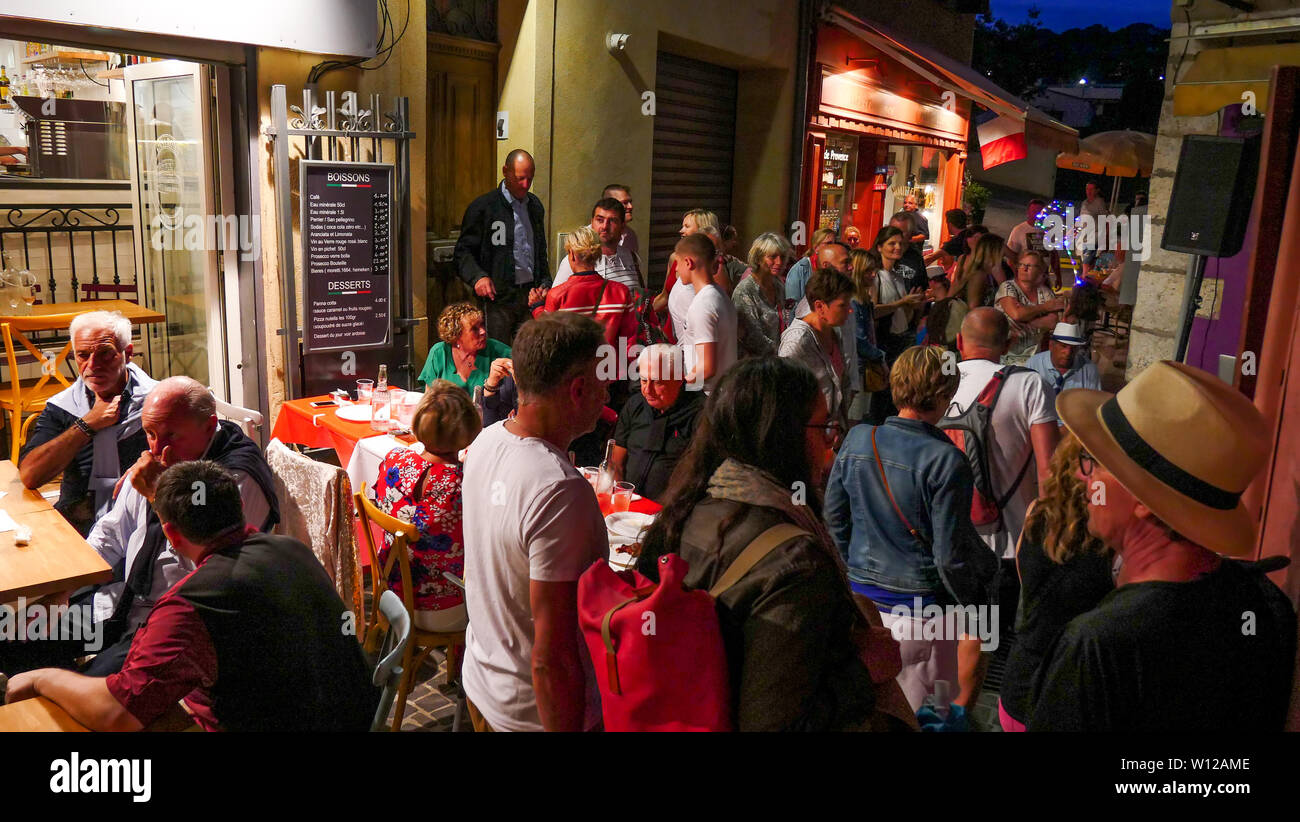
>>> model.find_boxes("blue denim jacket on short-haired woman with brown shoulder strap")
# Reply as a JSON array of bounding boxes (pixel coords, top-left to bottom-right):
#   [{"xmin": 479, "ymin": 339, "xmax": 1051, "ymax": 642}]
[{"xmin": 824, "ymin": 416, "xmax": 997, "ymax": 605}]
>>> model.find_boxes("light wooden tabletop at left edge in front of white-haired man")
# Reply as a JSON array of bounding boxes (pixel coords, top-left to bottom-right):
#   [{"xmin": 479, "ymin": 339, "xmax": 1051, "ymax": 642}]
[{"xmin": 0, "ymin": 460, "xmax": 113, "ymax": 602}]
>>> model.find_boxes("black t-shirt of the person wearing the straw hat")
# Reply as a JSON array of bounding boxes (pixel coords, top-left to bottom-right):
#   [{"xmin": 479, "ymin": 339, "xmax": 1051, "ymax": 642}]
[{"xmin": 1028, "ymin": 561, "xmax": 1296, "ymax": 732}]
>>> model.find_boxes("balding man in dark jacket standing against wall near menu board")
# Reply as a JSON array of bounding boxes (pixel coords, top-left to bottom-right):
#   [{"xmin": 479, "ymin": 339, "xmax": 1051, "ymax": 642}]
[{"xmin": 455, "ymin": 148, "xmax": 551, "ymax": 345}]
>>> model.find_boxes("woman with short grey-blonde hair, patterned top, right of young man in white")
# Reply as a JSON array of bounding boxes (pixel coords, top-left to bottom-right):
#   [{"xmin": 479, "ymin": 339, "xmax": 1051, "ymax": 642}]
[{"xmin": 732, "ymin": 232, "xmax": 794, "ymax": 356}]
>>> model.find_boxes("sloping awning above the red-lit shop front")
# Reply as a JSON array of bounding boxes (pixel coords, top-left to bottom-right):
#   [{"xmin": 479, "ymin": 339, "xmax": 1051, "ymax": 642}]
[{"xmin": 824, "ymin": 7, "xmax": 1079, "ymax": 153}]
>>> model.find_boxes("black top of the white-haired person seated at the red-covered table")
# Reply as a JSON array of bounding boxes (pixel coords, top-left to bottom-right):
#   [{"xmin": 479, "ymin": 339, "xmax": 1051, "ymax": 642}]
[{"xmin": 614, "ymin": 390, "xmax": 705, "ymax": 502}]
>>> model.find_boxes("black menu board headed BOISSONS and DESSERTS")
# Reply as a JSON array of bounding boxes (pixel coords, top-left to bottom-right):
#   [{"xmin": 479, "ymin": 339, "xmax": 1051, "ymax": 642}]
[{"xmin": 299, "ymin": 160, "xmax": 393, "ymax": 352}]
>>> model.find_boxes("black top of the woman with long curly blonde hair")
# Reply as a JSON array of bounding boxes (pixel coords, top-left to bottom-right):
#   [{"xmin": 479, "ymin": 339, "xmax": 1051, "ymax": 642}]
[{"xmin": 998, "ymin": 533, "xmax": 1115, "ymax": 722}]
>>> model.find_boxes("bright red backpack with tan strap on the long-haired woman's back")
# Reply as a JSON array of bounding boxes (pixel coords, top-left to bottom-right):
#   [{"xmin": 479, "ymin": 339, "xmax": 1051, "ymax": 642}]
[{"xmin": 577, "ymin": 524, "xmax": 807, "ymax": 731}]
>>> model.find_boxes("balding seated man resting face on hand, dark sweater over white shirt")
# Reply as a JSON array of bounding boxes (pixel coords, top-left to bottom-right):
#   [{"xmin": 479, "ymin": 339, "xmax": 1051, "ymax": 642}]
[{"xmin": 78, "ymin": 377, "xmax": 280, "ymax": 676}]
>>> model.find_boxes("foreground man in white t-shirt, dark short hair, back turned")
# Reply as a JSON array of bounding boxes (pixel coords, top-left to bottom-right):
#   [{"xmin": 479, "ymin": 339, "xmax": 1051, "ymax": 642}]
[{"xmin": 462, "ymin": 311, "xmax": 608, "ymax": 731}]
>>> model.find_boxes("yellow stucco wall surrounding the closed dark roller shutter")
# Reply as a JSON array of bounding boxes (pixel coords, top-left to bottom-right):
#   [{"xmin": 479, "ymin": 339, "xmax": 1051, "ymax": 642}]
[{"xmin": 498, "ymin": 0, "xmax": 798, "ymax": 275}]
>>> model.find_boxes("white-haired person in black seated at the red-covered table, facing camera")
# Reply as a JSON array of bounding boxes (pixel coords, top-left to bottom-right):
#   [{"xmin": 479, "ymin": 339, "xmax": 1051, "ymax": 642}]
[{"xmin": 614, "ymin": 343, "xmax": 705, "ymax": 499}]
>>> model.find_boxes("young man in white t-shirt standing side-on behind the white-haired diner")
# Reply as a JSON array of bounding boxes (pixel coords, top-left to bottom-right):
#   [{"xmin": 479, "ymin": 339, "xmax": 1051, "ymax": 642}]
[{"xmin": 670, "ymin": 233, "xmax": 737, "ymax": 394}]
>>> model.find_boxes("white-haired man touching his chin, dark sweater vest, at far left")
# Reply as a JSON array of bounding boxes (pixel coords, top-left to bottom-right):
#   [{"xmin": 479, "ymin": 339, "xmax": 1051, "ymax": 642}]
[{"xmin": 18, "ymin": 311, "xmax": 155, "ymax": 536}]
